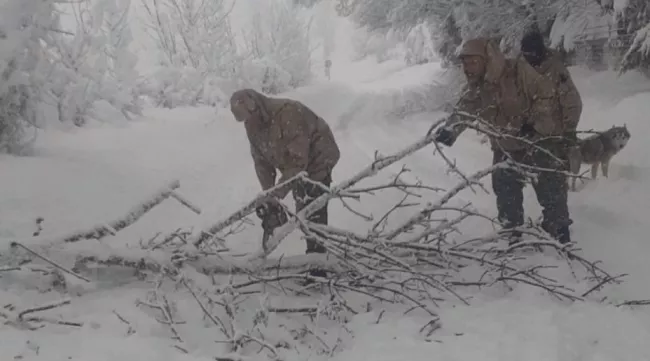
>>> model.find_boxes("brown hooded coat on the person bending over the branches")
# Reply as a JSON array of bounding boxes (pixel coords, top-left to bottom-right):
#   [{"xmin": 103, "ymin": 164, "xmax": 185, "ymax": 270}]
[{"xmin": 231, "ymin": 89, "xmax": 340, "ymax": 198}]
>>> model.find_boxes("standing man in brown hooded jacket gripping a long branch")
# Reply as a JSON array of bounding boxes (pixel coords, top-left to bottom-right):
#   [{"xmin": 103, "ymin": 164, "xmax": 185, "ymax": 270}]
[{"xmin": 436, "ymin": 38, "xmax": 570, "ymax": 243}]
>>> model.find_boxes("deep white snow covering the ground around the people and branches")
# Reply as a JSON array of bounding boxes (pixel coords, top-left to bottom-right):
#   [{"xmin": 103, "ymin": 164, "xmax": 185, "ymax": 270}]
[{"xmin": 0, "ymin": 1, "xmax": 650, "ymax": 361}]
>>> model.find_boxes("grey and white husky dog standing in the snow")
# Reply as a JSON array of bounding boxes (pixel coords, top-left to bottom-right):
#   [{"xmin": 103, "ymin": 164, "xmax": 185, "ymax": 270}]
[{"xmin": 568, "ymin": 125, "xmax": 630, "ymax": 191}]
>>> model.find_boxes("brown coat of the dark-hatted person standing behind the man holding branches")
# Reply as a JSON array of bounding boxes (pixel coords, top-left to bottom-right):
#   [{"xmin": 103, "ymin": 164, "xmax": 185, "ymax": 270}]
[{"xmin": 535, "ymin": 49, "xmax": 582, "ymax": 132}]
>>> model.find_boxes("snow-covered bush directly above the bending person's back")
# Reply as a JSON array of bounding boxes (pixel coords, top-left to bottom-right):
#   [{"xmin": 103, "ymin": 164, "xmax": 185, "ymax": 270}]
[{"xmin": 240, "ymin": 0, "xmax": 312, "ymax": 94}]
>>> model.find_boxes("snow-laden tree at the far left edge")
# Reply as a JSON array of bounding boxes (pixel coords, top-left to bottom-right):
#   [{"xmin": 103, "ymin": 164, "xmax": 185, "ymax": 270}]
[{"xmin": 0, "ymin": 0, "xmax": 67, "ymax": 152}]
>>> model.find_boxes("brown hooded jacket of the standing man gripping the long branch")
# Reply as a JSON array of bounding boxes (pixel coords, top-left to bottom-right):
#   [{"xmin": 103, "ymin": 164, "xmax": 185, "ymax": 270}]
[{"xmin": 447, "ymin": 38, "xmax": 564, "ymax": 151}]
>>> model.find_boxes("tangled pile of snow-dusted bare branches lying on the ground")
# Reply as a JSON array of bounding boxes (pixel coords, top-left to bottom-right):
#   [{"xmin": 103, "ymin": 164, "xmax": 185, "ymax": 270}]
[{"xmin": 0, "ymin": 123, "xmax": 632, "ymax": 360}]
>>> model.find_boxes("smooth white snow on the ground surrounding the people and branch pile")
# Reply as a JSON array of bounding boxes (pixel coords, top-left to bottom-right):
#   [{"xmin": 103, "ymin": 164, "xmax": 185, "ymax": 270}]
[{"xmin": 0, "ymin": 9, "xmax": 650, "ymax": 361}]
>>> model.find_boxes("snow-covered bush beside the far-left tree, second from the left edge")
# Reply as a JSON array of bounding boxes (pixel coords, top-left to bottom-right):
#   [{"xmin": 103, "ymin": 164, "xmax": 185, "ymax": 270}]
[{"xmin": 50, "ymin": 0, "xmax": 141, "ymax": 126}]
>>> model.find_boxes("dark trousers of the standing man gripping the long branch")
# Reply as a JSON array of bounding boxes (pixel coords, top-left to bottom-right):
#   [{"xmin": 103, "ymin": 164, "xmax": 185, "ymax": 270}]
[{"xmin": 492, "ymin": 146, "xmax": 570, "ymax": 237}]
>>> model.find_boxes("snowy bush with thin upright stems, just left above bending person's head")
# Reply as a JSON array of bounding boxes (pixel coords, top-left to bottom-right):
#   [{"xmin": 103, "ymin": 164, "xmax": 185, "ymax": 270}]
[{"xmin": 142, "ymin": 0, "xmax": 241, "ymax": 107}]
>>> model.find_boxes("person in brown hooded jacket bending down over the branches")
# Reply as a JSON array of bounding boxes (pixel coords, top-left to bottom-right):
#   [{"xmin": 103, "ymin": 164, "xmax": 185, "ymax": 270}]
[{"xmin": 230, "ymin": 89, "xmax": 340, "ymax": 253}]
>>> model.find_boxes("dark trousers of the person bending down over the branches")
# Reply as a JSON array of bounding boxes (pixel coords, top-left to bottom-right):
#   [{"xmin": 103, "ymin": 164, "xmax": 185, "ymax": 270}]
[{"xmin": 293, "ymin": 173, "xmax": 332, "ymax": 253}]
